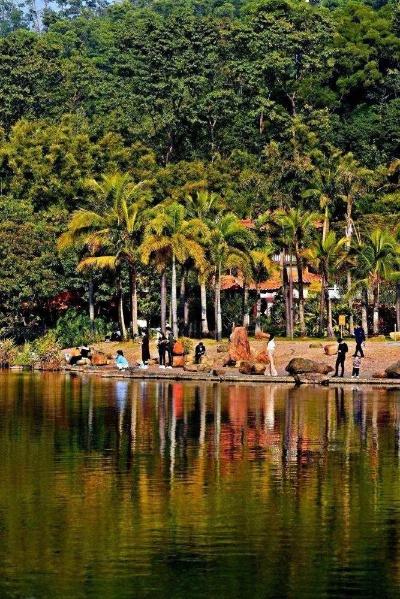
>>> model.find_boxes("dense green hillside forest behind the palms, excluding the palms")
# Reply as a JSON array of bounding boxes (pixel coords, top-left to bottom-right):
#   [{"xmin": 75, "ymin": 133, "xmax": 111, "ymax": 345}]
[{"xmin": 0, "ymin": 0, "xmax": 400, "ymax": 340}]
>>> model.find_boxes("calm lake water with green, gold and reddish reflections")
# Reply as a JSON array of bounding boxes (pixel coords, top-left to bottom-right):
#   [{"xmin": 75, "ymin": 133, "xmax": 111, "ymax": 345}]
[{"xmin": 0, "ymin": 373, "xmax": 400, "ymax": 599}]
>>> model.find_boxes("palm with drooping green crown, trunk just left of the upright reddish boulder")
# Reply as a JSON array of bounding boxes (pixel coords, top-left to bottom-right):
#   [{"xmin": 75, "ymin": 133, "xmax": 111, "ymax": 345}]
[{"xmin": 209, "ymin": 212, "xmax": 254, "ymax": 341}]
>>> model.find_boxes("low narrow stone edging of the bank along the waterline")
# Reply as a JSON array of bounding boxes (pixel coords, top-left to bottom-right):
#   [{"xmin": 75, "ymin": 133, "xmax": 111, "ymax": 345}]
[{"xmin": 62, "ymin": 368, "xmax": 400, "ymax": 387}]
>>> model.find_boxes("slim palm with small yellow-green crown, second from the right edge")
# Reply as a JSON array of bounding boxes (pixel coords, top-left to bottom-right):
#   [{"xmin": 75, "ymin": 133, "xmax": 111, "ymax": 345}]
[{"xmin": 303, "ymin": 231, "xmax": 348, "ymax": 337}]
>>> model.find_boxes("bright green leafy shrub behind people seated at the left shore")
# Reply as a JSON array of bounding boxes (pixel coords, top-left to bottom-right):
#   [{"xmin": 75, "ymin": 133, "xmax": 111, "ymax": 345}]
[{"xmin": 55, "ymin": 310, "xmax": 111, "ymax": 347}]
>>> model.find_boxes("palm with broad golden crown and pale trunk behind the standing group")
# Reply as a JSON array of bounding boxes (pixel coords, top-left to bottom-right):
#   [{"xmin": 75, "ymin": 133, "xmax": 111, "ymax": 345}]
[{"xmin": 141, "ymin": 202, "xmax": 209, "ymax": 337}]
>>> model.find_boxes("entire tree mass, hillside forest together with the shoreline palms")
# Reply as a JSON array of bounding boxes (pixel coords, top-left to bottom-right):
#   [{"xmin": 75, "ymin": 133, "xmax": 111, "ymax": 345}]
[{"xmin": 0, "ymin": 0, "xmax": 400, "ymax": 346}]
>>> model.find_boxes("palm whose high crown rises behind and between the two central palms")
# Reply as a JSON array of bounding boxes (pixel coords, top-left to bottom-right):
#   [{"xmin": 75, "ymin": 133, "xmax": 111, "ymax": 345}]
[{"xmin": 186, "ymin": 190, "xmax": 226, "ymax": 336}]
